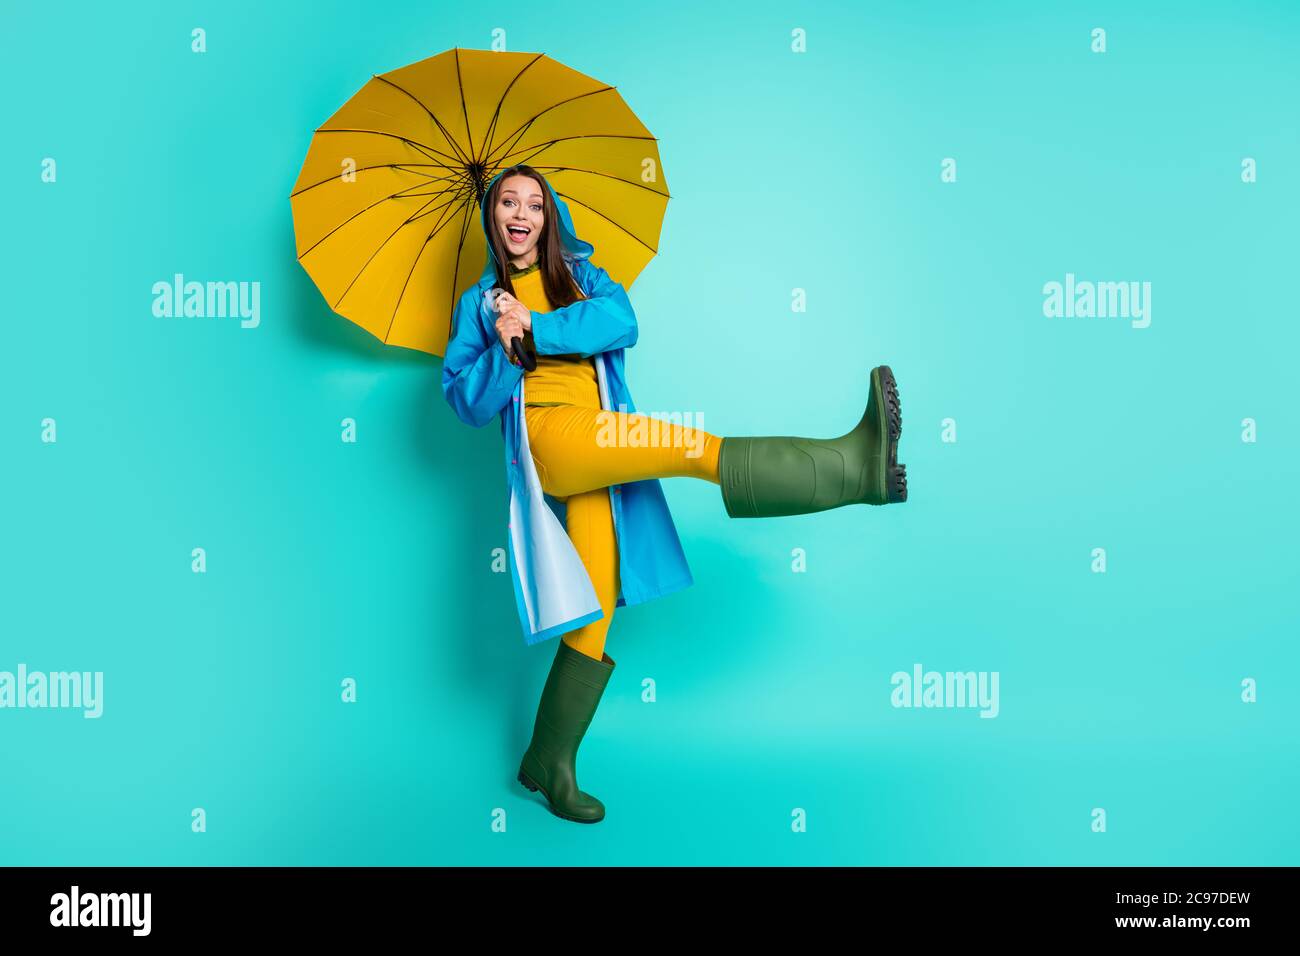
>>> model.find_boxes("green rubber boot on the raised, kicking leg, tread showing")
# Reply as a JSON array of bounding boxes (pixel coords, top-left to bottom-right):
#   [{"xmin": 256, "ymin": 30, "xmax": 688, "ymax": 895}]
[{"xmin": 718, "ymin": 365, "xmax": 907, "ymax": 518}]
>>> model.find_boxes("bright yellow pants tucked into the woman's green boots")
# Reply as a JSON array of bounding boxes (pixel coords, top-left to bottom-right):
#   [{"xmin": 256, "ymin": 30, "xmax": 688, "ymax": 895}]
[{"xmin": 524, "ymin": 402, "xmax": 722, "ymax": 661}]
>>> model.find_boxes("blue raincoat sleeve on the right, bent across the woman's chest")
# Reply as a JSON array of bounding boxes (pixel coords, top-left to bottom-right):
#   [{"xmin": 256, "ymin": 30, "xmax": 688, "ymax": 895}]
[{"xmin": 522, "ymin": 259, "xmax": 637, "ymax": 358}]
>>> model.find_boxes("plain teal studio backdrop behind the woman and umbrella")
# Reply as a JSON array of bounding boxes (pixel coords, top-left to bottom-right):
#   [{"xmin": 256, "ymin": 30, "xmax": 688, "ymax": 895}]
[{"xmin": 0, "ymin": 0, "xmax": 1300, "ymax": 865}]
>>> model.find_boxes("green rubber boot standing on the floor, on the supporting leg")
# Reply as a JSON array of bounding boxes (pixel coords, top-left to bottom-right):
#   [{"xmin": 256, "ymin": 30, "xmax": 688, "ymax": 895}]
[{"xmin": 519, "ymin": 640, "xmax": 614, "ymax": 823}]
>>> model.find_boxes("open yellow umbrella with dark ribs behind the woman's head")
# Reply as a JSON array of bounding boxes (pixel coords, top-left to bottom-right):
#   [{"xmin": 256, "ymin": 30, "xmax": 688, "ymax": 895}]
[{"xmin": 290, "ymin": 47, "xmax": 668, "ymax": 355}]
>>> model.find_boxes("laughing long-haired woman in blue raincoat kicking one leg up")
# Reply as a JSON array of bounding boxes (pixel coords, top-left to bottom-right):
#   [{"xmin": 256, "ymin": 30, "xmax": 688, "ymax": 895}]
[{"xmin": 442, "ymin": 165, "xmax": 907, "ymax": 823}]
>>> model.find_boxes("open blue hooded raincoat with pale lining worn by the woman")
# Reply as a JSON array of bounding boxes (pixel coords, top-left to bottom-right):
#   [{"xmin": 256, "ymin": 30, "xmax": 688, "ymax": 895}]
[{"xmin": 442, "ymin": 173, "xmax": 693, "ymax": 644}]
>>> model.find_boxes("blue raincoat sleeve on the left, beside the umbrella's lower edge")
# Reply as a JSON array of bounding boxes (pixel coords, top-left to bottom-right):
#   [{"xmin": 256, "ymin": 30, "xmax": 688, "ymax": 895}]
[{"xmin": 442, "ymin": 289, "xmax": 524, "ymax": 428}]
